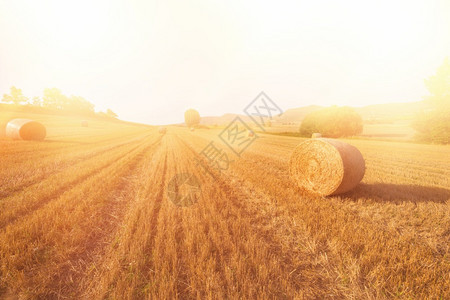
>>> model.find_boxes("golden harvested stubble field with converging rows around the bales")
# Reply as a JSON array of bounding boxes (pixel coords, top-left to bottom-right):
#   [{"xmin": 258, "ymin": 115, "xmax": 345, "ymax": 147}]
[{"xmin": 0, "ymin": 116, "xmax": 450, "ymax": 299}]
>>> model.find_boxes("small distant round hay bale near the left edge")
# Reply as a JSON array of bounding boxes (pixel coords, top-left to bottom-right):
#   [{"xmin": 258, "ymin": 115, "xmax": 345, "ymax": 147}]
[{"xmin": 6, "ymin": 119, "xmax": 47, "ymax": 141}]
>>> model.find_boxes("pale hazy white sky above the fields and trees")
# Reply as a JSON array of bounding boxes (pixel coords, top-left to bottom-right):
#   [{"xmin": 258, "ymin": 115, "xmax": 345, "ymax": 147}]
[{"xmin": 0, "ymin": 0, "xmax": 450, "ymax": 124}]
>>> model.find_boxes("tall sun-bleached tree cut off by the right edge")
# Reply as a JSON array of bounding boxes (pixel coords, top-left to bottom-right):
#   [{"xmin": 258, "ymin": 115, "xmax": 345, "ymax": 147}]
[{"xmin": 413, "ymin": 58, "xmax": 450, "ymax": 144}]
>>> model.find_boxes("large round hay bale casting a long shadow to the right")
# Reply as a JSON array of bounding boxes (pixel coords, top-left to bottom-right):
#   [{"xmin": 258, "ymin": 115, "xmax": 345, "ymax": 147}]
[{"xmin": 289, "ymin": 138, "xmax": 365, "ymax": 196}]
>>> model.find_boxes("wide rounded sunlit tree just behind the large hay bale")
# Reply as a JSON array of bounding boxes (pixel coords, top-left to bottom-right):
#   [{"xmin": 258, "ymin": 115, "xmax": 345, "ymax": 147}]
[{"xmin": 300, "ymin": 106, "xmax": 363, "ymax": 138}]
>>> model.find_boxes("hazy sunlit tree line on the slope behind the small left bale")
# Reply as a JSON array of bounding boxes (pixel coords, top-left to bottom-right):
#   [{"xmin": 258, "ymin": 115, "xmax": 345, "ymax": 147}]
[{"xmin": 2, "ymin": 86, "xmax": 118, "ymax": 118}]
